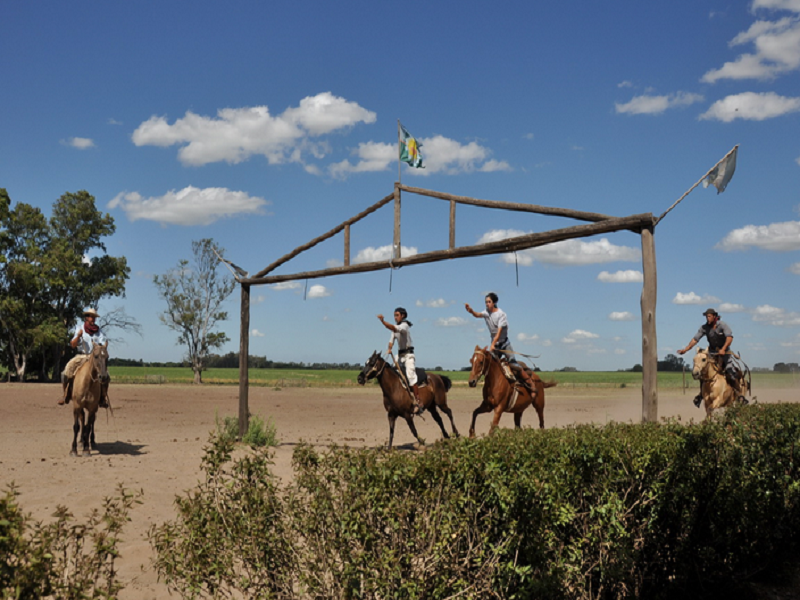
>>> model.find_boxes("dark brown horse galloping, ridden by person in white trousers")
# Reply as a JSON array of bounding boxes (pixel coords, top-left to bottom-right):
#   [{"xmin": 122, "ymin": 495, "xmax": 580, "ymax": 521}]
[{"xmin": 358, "ymin": 351, "xmax": 459, "ymax": 448}]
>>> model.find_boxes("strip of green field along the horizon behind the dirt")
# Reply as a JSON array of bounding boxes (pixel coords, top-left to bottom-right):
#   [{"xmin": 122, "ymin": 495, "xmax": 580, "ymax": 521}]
[{"xmin": 108, "ymin": 367, "xmax": 800, "ymax": 392}]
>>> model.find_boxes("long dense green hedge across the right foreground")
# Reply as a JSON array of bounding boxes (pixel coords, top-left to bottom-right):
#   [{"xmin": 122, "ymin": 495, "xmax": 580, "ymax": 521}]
[{"xmin": 153, "ymin": 404, "xmax": 800, "ymax": 599}]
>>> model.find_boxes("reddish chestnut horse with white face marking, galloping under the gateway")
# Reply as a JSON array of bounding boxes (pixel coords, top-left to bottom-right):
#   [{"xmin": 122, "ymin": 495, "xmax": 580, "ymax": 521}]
[{"xmin": 469, "ymin": 346, "xmax": 556, "ymax": 438}]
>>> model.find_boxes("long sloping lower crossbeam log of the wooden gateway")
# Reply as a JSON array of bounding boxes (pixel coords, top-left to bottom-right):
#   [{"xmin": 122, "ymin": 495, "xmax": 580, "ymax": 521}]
[{"xmin": 242, "ymin": 213, "xmax": 654, "ymax": 285}]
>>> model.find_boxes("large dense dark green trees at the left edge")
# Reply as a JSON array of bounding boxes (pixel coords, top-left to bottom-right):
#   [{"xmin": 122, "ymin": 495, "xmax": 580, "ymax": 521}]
[{"xmin": 0, "ymin": 189, "xmax": 130, "ymax": 380}]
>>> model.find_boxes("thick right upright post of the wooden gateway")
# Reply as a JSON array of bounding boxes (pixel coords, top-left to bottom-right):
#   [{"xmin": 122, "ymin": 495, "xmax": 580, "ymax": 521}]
[{"xmin": 641, "ymin": 226, "xmax": 658, "ymax": 423}]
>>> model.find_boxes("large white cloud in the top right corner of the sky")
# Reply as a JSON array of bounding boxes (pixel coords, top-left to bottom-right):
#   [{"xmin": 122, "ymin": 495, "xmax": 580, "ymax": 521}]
[{"xmin": 702, "ymin": 8, "xmax": 800, "ymax": 83}]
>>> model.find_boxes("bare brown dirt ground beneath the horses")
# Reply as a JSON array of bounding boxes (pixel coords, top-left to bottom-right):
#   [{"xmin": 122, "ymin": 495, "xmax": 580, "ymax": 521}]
[{"xmin": 0, "ymin": 383, "xmax": 800, "ymax": 600}]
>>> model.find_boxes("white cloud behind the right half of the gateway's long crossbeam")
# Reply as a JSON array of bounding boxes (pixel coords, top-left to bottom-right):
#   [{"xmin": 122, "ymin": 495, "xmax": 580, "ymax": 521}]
[{"xmin": 478, "ymin": 229, "xmax": 642, "ymax": 266}]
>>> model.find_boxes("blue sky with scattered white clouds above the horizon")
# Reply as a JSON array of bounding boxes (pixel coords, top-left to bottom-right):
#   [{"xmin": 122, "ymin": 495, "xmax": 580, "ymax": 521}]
[{"xmin": 0, "ymin": 0, "xmax": 800, "ymax": 370}]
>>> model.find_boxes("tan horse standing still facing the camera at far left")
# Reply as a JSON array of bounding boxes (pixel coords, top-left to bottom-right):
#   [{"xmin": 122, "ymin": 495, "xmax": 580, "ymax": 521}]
[{"xmin": 70, "ymin": 342, "xmax": 108, "ymax": 456}]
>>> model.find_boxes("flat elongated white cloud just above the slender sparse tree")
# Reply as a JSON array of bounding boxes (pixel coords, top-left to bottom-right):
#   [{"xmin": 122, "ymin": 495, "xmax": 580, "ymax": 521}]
[{"xmin": 108, "ymin": 186, "xmax": 269, "ymax": 225}]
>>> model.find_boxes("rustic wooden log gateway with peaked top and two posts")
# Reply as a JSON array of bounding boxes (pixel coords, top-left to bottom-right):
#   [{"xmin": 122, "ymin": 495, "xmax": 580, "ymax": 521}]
[{"xmin": 231, "ymin": 182, "xmax": 656, "ymax": 436}]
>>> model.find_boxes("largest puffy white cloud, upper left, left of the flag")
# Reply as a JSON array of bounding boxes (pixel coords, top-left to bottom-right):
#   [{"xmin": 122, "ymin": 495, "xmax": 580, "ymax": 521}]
[{"xmin": 132, "ymin": 92, "xmax": 377, "ymax": 170}]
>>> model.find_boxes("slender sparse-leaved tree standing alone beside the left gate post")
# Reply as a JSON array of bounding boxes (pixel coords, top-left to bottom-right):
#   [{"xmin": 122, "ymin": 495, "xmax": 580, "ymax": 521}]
[{"xmin": 153, "ymin": 238, "xmax": 236, "ymax": 383}]
